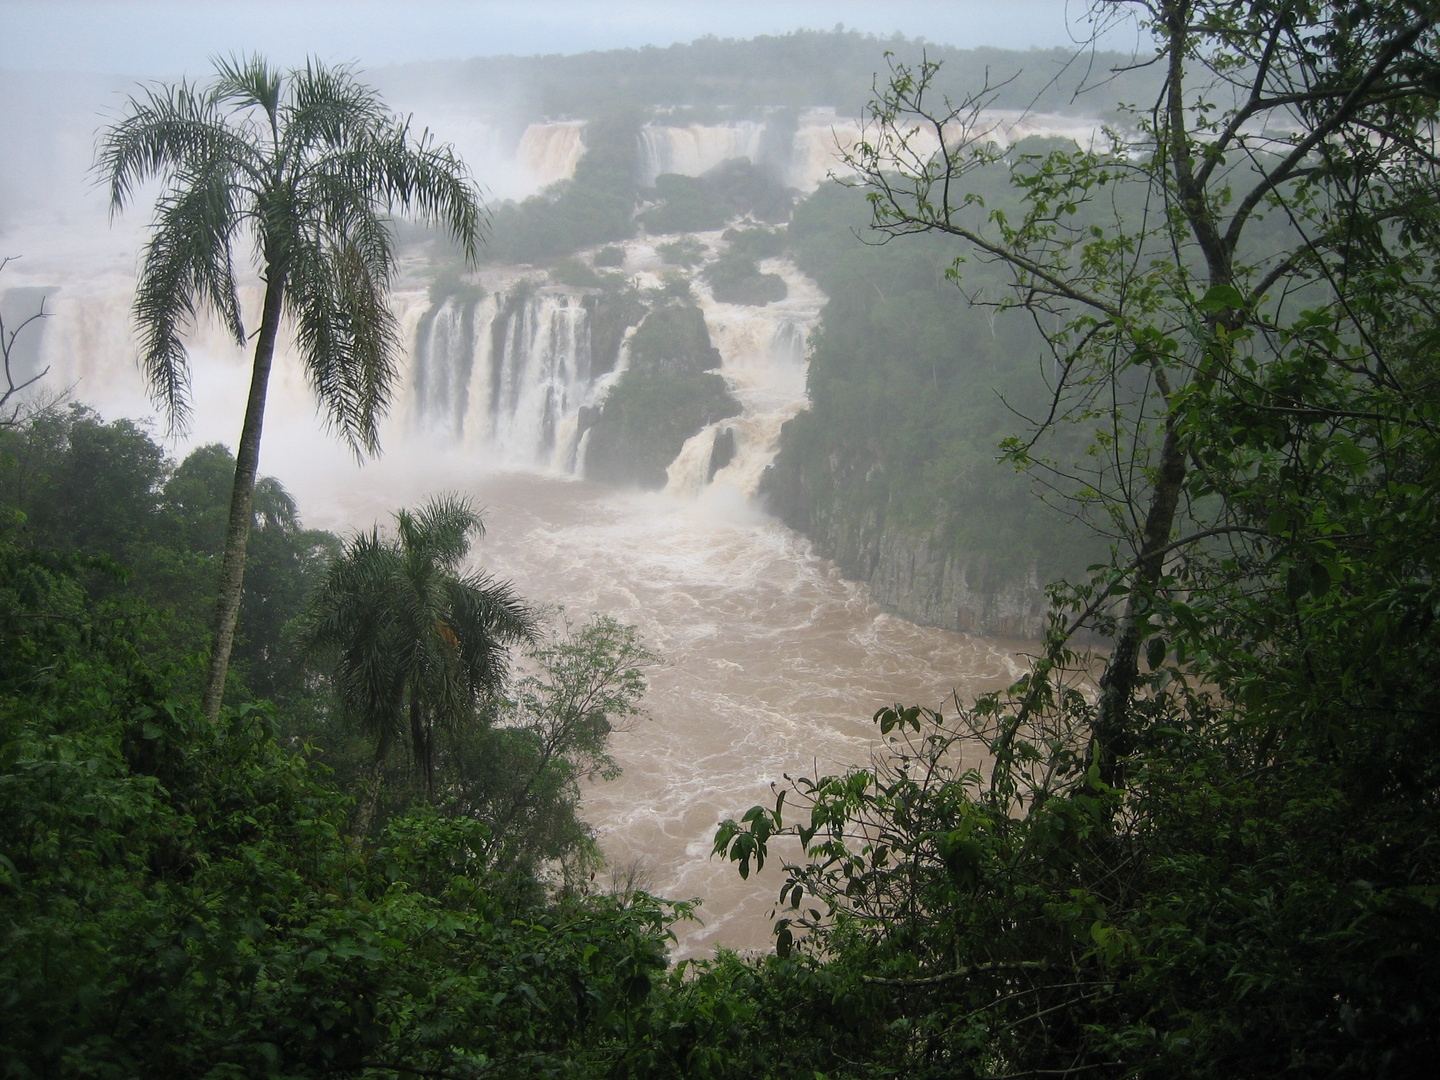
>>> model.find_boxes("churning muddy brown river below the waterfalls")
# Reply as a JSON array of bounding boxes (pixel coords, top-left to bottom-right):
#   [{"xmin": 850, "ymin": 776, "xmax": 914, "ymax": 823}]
[{"xmin": 297, "ymin": 455, "xmax": 1025, "ymax": 956}]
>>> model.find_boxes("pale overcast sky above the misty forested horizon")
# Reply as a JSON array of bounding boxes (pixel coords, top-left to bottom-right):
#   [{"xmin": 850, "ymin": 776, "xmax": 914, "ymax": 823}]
[{"xmin": 0, "ymin": 0, "xmax": 1135, "ymax": 78}]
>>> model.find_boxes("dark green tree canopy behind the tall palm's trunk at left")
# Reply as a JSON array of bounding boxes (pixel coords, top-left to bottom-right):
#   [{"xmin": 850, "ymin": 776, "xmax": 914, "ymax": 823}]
[{"xmin": 0, "ymin": 405, "xmax": 338, "ymax": 704}]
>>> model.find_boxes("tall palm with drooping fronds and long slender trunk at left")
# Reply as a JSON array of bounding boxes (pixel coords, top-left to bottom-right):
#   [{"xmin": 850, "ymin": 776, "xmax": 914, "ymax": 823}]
[{"xmin": 95, "ymin": 56, "xmax": 484, "ymax": 720}]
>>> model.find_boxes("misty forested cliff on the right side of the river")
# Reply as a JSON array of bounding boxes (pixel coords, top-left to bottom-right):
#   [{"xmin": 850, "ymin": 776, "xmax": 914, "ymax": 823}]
[{"xmin": 766, "ymin": 180, "xmax": 1102, "ymax": 596}]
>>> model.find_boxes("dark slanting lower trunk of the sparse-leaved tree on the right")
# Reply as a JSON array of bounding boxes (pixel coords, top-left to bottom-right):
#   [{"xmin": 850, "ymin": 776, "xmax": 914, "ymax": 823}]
[{"xmin": 1089, "ymin": 416, "xmax": 1187, "ymax": 788}]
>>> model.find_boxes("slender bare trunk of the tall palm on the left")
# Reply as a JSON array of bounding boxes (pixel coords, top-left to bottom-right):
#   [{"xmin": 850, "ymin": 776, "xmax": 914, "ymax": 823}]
[{"xmin": 204, "ymin": 272, "xmax": 285, "ymax": 723}]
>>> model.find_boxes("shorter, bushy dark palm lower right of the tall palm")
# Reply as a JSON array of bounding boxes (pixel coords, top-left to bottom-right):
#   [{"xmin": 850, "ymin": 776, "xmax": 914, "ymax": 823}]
[{"xmin": 301, "ymin": 497, "xmax": 536, "ymax": 793}]
